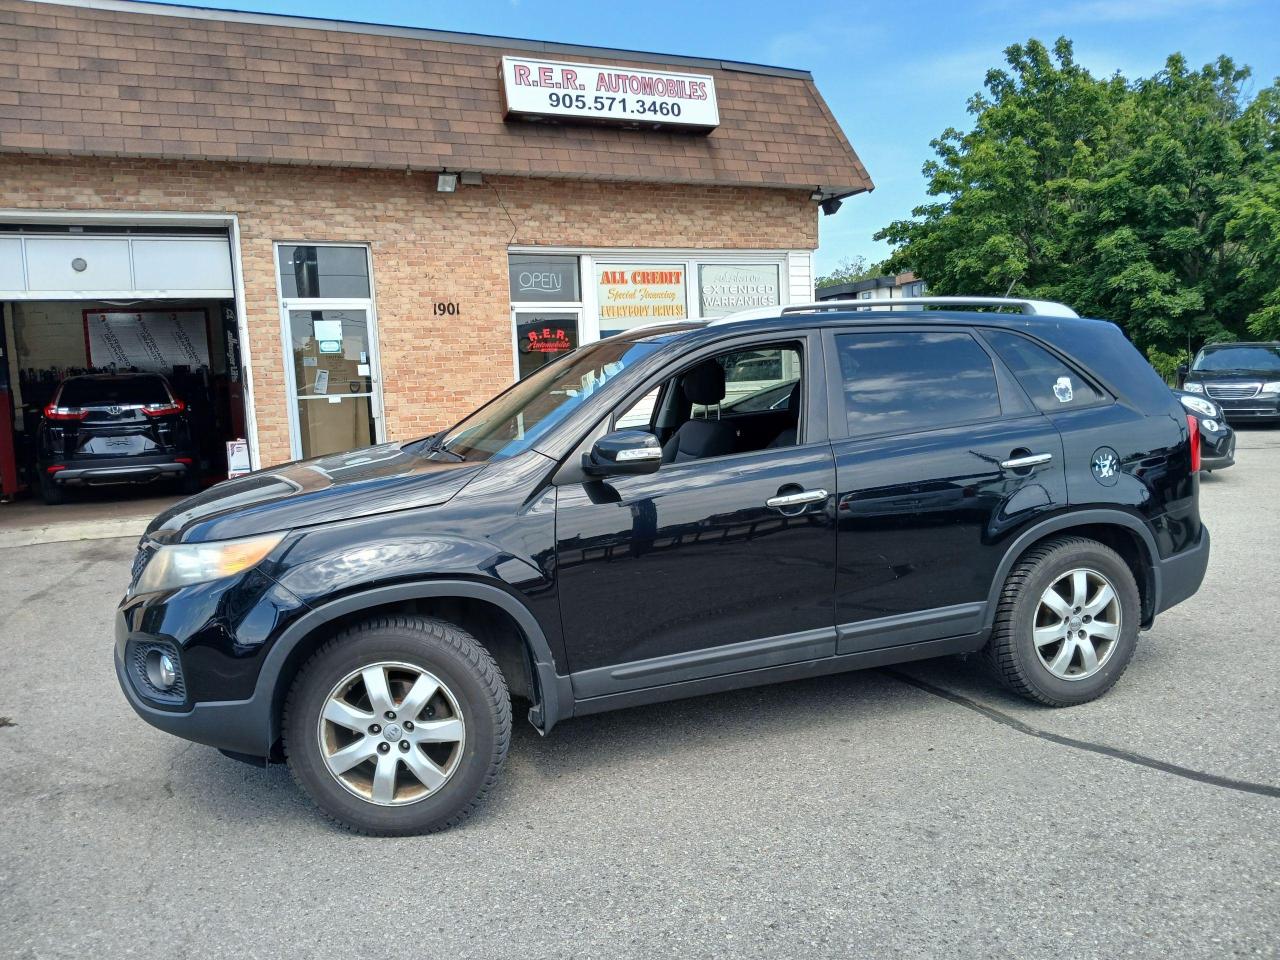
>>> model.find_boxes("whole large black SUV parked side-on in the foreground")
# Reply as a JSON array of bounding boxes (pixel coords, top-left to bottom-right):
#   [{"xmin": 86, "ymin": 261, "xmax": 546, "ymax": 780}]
[{"xmin": 115, "ymin": 301, "xmax": 1208, "ymax": 833}]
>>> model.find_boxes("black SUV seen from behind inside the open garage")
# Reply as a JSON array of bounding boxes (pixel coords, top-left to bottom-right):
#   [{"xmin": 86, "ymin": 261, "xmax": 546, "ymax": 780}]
[{"xmin": 36, "ymin": 374, "xmax": 197, "ymax": 503}]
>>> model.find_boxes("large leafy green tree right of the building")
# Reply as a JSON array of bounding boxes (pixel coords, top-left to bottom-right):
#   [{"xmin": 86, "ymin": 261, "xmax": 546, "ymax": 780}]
[{"xmin": 877, "ymin": 38, "xmax": 1280, "ymax": 364}]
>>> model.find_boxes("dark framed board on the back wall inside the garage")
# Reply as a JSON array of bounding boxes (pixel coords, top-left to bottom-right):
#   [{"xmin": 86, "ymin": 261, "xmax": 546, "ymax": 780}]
[{"xmin": 84, "ymin": 310, "xmax": 209, "ymax": 374}]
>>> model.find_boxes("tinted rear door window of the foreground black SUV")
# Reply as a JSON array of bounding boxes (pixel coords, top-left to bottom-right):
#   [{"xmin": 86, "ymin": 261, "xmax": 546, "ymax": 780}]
[{"xmin": 836, "ymin": 330, "xmax": 1000, "ymax": 436}]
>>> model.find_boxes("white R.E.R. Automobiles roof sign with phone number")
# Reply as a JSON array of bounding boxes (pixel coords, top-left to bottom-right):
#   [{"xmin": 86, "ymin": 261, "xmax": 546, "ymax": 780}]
[{"xmin": 502, "ymin": 56, "xmax": 719, "ymax": 131}]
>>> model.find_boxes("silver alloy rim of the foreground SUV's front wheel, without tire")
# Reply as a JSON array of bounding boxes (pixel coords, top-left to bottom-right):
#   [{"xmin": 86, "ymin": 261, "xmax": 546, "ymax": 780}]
[{"xmin": 316, "ymin": 662, "xmax": 466, "ymax": 806}]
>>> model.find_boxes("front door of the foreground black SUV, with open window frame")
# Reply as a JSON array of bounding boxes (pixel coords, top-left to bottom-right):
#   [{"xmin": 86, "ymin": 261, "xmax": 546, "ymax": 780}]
[{"xmin": 556, "ymin": 333, "xmax": 836, "ymax": 699}]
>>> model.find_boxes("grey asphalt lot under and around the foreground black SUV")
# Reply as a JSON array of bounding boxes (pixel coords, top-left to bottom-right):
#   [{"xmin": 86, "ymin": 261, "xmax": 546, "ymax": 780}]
[{"xmin": 0, "ymin": 429, "xmax": 1280, "ymax": 960}]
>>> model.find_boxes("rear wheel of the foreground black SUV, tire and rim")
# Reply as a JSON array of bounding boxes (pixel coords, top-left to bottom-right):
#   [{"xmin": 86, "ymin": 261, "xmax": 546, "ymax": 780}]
[{"xmin": 984, "ymin": 536, "xmax": 1142, "ymax": 707}]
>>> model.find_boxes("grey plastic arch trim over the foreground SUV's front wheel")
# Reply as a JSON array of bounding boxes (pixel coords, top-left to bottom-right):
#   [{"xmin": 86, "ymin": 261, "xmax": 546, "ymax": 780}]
[{"xmin": 253, "ymin": 580, "xmax": 572, "ymax": 751}]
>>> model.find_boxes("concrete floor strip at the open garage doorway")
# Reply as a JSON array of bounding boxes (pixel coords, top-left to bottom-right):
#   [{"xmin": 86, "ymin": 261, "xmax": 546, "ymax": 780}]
[{"xmin": 0, "ymin": 489, "xmax": 182, "ymax": 547}]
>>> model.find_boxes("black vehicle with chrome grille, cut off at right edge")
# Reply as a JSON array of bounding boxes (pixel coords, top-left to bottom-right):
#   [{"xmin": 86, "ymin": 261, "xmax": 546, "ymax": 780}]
[{"xmin": 1178, "ymin": 342, "xmax": 1280, "ymax": 422}]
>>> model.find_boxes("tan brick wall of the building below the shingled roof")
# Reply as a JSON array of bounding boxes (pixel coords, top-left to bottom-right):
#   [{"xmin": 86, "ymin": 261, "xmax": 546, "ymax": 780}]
[{"xmin": 0, "ymin": 156, "xmax": 818, "ymax": 465}]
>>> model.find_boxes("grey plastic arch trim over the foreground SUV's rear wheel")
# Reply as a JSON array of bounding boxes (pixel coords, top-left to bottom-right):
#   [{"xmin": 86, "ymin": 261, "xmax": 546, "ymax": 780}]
[{"xmin": 983, "ymin": 509, "xmax": 1160, "ymax": 631}]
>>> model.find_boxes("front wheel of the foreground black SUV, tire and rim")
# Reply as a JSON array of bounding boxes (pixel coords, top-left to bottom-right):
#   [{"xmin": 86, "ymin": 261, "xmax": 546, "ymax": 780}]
[{"xmin": 282, "ymin": 616, "xmax": 511, "ymax": 836}]
